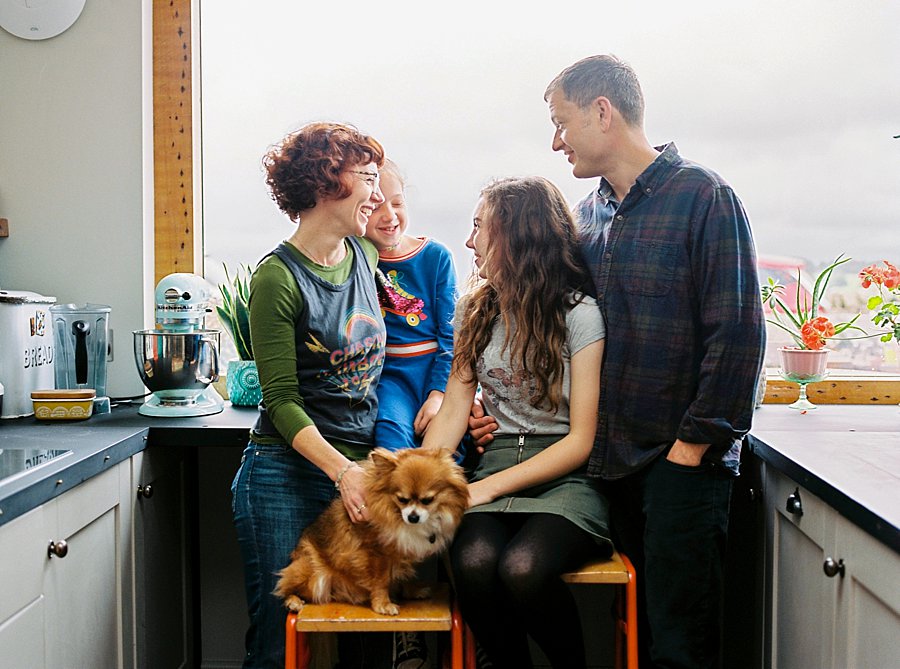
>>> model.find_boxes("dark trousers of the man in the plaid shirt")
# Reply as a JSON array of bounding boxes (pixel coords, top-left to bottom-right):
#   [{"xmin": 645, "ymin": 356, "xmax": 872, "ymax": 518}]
[{"xmin": 601, "ymin": 453, "xmax": 734, "ymax": 669}]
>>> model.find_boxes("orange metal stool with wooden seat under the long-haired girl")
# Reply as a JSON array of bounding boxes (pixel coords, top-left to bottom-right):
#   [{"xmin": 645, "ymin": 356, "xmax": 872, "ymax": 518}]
[{"xmin": 464, "ymin": 551, "xmax": 638, "ymax": 669}]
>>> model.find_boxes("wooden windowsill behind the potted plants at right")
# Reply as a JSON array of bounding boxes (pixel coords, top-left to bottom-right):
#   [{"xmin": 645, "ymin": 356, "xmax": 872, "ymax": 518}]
[{"xmin": 764, "ymin": 370, "xmax": 900, "ymax": 404}]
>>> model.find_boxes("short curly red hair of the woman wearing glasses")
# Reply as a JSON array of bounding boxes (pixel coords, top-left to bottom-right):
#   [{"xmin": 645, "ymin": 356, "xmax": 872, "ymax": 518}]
[{"xmin": 263, "ymin": 122, "xmax": 384, "ymax": 222}]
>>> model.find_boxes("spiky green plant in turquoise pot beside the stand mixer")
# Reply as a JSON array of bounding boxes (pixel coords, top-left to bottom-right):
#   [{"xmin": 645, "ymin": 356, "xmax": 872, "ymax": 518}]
[{"xmin": 216, "ymin": 265, "xmax": 262, "ymax": 406}]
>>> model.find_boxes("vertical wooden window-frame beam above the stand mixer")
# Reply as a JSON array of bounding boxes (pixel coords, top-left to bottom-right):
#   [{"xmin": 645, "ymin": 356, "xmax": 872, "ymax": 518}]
[{"xmin": 153, "ymin": 0, "xmax": 196, "ymax": 282}]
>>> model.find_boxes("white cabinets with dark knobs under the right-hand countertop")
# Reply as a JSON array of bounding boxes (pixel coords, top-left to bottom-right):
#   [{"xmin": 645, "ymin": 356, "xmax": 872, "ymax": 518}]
[{"xmin": 765, "ymin": 467, "xmax": 900, "ymax": 669}]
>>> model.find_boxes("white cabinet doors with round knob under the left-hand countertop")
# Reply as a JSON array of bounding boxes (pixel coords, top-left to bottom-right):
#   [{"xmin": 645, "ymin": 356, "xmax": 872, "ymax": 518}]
[{"xmin": 0, "ymin": 463, "xmax": 131, "ymax": 669}]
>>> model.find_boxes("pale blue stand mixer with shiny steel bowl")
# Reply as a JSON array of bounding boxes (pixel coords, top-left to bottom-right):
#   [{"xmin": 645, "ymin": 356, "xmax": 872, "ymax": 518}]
[{"xmin": 133, "ymin": 273, "xmax": 225, "ymax": 417}]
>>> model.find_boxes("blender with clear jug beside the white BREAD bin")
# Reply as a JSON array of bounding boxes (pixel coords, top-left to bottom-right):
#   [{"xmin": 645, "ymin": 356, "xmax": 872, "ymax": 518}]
[{"xmin": 50, "ymin": 303, "xmax": 111, "ymax": 413}]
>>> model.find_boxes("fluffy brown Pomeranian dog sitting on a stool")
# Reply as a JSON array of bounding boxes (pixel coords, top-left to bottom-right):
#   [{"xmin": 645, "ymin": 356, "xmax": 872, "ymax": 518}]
[{"xmin": 275, "ymin": 448, "xmax": 469, "ymax": 616}]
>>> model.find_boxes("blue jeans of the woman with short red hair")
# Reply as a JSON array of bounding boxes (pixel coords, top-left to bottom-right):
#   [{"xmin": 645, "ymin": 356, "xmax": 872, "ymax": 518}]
[{"xmin": 231, "ymin": 442, "xmax": 336, "ymax": 669}]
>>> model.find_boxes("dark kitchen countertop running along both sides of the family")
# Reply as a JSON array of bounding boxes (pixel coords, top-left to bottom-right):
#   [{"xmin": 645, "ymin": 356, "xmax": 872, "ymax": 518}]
[{"xmin": 0, "ymin": 402, "xmax": 900, "ymax": 552}]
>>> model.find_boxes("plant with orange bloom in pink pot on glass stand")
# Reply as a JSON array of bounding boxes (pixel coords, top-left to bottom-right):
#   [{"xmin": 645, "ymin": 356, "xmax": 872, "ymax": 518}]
[{"xmin": 761, "ymin": 254, "xmax": 865, "ymax": 409}]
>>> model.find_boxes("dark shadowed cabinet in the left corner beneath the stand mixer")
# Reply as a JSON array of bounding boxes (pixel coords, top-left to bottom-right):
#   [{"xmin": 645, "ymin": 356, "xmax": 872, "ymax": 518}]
[{"xmin": 131, "ymin": 447, "xmax": 194, "ymax": 669}]
